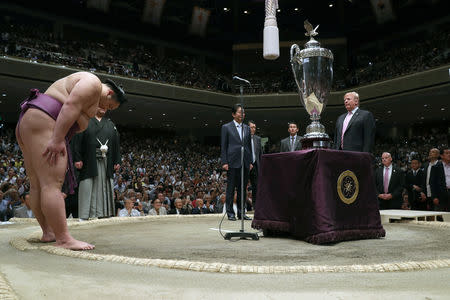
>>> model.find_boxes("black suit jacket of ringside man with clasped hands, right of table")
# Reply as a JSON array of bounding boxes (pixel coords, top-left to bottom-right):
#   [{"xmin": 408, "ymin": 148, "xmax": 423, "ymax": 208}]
[{"xmin": 374, "ymin": 165, "xmax": 405, "ymax": 209}]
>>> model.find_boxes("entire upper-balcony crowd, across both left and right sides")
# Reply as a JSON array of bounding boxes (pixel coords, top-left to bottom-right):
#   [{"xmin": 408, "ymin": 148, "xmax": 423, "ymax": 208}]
[{"xmin": 0, "ymin": 17, "xmax": 450, "ymax": 94}]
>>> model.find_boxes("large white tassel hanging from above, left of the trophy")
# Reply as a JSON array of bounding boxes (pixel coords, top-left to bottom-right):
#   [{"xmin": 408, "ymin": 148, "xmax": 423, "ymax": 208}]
[{"xmin": 263, "ymin": 0, "xmax": 280, "ymax": 60}]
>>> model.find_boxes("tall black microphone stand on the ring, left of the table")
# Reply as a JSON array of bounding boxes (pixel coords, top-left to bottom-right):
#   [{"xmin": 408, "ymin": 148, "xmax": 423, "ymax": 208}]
[{"xmin": 224, "ymin": 76, "xmax": 259, "ymax": 240}]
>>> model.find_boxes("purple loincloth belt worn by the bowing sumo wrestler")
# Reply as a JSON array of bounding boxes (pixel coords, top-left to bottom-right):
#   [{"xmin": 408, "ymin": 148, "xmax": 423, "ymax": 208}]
[{"xmin": 17, "ymin": 89, "xmax": 80, "ymax": 194}]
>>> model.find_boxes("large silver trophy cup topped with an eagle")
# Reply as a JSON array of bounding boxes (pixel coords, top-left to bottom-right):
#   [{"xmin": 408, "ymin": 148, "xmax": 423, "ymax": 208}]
[{"xmin": 291, "ymin": 21, "xmax": 333, "ymax": 149}]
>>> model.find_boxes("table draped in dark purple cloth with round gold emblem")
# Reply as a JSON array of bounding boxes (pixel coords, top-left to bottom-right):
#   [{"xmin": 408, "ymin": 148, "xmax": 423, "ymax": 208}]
[{"xmin": 252, "ymin": 149, "xmax": 386, "ymax": 244}]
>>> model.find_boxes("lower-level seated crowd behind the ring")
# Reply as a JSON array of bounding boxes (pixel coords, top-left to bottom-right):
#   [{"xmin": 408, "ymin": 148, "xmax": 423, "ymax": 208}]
[{"xmin": 0, "ymin": 123, "xmax": 449, "ymax": 221}]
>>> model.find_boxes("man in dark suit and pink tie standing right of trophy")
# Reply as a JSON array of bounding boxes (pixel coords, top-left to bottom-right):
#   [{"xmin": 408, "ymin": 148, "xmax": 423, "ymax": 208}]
[{"xmin": 334, "ymin": 92, "xmax": 375, "ymax": 152}]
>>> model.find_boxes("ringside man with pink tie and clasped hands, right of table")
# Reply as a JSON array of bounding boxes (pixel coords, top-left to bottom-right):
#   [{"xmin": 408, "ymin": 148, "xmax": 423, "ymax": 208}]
[{"xmin": 375, "ymin": 152, "xmax": 405, "ymax": 209}]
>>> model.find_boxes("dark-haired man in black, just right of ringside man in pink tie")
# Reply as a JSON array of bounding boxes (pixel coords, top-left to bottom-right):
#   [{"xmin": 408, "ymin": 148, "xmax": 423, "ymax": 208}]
[{"xmin": 405, "ymin": 157, "xmax": 427, "ymax": 210}]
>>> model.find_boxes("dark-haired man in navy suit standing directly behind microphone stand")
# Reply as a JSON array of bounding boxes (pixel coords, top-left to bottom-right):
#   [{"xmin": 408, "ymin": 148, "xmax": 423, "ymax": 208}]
[{"xmin": 220, "ymin": 104, "xmax": 253, "ymax": 221}]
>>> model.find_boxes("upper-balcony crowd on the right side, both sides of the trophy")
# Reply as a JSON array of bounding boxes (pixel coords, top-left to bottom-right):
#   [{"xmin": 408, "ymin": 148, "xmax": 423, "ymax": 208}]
[{"xmin": 243, "ymin": 30, "xmax": 450, "ymax": 93}]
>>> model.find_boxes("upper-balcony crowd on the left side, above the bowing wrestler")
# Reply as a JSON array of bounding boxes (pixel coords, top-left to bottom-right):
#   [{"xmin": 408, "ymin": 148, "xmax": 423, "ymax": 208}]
[{"xmin": 0, "ymin": 23, "xmax": 231, "ymax": 92}]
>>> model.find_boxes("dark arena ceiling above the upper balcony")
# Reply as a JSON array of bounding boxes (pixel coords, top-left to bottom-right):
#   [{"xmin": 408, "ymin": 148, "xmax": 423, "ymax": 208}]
[{"xmin": 2, "ymin": 0, "xmax": 448, "ymax": 54}]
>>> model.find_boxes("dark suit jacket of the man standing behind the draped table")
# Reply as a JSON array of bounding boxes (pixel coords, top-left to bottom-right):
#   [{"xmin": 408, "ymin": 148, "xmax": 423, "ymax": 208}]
[{"xmin": 334, "ymin": 108, "xmax": 375, "ymax": 152}]
